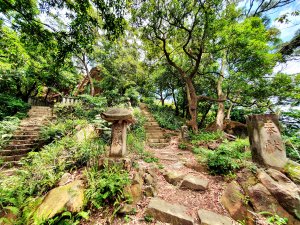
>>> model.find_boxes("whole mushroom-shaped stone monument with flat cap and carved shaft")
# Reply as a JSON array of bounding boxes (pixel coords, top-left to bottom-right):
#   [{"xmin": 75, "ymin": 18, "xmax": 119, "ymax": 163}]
[{"xmin": 101, "ymin": 108, "xmax": 134, "ymax": 158}]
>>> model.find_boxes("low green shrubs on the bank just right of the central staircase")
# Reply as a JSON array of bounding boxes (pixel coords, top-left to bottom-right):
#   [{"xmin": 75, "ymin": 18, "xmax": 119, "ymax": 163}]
[{"xmin": 148, "ymin": 104, "xmax": 183, "ymax": 130}]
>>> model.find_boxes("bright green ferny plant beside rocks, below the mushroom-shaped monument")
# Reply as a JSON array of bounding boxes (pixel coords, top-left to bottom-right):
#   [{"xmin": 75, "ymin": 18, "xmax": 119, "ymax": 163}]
[{"xmin": 85, "ymin": 164, "xmax": 130, "ymax": 209}]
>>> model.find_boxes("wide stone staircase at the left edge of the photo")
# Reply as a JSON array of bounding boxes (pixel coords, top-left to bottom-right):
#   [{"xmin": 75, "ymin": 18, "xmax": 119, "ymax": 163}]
[{"xmin": 0, "ymin": 106, "xmax": 52, "ymax": 166}]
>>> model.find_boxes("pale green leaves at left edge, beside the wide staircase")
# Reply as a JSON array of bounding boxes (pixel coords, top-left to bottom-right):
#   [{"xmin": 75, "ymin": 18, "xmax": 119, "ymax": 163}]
[{"xmin": 0, "ymin": 117, "xmax": 20, "ymax": 149}]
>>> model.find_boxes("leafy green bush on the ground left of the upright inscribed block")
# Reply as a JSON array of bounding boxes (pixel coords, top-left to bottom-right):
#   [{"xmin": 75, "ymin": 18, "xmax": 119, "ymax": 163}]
[{"xmin": 207, "ymin": 139, "xmax": 251, "ymax": 175}]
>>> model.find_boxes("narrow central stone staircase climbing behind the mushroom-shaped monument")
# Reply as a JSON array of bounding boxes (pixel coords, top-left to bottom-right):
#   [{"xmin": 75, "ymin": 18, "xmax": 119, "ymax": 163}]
[{"xmin": 140, "ymin": 103, "xmax": 169, "ymax": 148}]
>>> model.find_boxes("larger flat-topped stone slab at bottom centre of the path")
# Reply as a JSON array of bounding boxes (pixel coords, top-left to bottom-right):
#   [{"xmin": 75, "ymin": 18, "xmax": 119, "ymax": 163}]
[{"xmin": 145, "ymin": 198, "xmax": 194, "ymax": 225}]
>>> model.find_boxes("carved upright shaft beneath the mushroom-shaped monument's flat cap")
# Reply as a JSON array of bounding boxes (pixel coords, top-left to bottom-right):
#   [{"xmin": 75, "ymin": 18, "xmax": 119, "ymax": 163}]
[{"xmin": 109, "ymin": 120, "xmax": 127, "ymax": 157}]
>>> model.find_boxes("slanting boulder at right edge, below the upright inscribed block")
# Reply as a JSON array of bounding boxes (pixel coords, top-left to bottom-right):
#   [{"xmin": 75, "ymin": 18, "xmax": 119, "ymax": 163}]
[{"xmin": 258, "ymin": 169, "xmax": 300, "ymax": 219}]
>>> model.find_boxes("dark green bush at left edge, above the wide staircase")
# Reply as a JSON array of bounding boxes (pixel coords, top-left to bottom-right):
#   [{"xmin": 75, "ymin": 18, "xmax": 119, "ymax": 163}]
[{"xmin": 0, "ymin": 94, "xmax": 29, "ymax": 120}]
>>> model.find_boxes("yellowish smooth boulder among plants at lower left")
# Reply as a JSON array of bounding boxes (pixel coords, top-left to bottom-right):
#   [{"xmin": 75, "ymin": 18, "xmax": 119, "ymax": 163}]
[{"xmin": 34, "ymin": 180, "xmax": 84, "ymax": 221}]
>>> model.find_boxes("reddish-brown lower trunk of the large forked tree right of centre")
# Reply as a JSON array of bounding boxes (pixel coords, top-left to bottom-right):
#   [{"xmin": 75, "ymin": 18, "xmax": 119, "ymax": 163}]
[{"xmin": 186, "ymin": 77, "xmax": 198, "ymax": 133}]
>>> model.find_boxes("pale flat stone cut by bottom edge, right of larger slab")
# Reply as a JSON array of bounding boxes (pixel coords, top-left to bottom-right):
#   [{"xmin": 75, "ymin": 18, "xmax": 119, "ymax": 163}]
[{"xmin": 198, "ymin": 209, "xmax": 237, "ymax": 225}]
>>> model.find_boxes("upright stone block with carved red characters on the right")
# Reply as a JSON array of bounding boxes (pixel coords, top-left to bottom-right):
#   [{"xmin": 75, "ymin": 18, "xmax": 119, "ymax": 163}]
[{"xmin": 247, "ymin": 114, "xmax": 287, "ymax": 169}]
